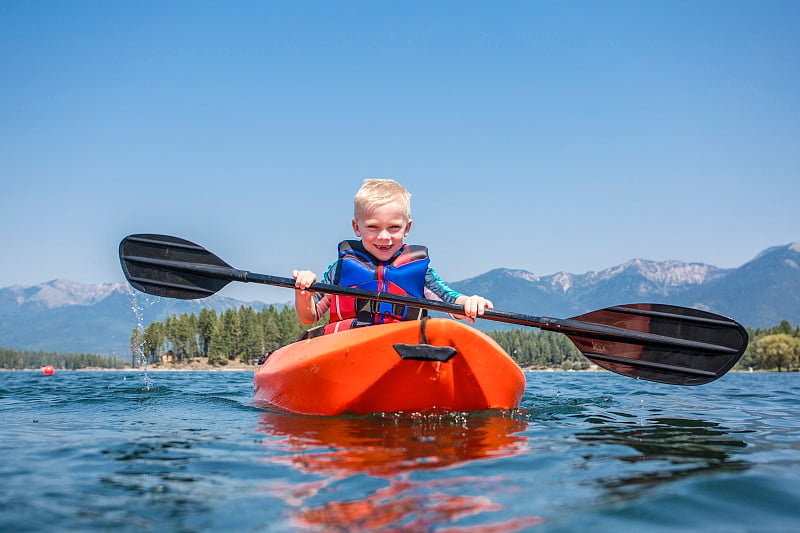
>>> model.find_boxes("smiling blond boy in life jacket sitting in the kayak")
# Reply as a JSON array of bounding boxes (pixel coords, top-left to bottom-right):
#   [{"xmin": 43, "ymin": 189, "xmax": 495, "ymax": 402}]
[{"xmin": 292, "ymin": 179, "xmax": 493, "ymax": 333}]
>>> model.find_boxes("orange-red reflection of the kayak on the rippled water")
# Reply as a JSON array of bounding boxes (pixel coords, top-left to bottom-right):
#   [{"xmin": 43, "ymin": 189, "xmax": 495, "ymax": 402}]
[{"xmin": 259, "ymin": 412, "xmax": 540, "ymax": 532}]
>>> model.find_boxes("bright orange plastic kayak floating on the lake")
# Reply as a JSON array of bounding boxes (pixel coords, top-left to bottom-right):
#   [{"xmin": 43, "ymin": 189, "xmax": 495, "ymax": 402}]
[{"xmin": 253, "ymin": 318, "xmax": 525, "ymax": 415}]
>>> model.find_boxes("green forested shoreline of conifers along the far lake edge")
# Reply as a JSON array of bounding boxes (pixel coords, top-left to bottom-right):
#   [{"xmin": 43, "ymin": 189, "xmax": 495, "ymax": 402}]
[{"xmin": 0, "ymin": 306, "xmax": 800, "ymax": 371}]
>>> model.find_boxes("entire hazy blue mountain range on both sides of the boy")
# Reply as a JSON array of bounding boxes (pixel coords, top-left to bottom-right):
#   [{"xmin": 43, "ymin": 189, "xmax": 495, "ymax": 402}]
[{"xmin": 0, "ymin": 242, "xmax": 800, "ymax": 357}]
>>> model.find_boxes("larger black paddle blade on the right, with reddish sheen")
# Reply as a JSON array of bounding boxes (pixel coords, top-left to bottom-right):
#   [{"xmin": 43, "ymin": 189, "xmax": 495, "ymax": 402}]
[{"xmin": 567, "ymin": 304, "xmax": 748, "ymax": 385}]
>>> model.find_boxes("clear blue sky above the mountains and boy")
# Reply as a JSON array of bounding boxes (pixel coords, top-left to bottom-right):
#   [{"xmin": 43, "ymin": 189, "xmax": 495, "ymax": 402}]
[{"xmin": 0, "ymin": 0, "xmax": 800, "ymax": 302}]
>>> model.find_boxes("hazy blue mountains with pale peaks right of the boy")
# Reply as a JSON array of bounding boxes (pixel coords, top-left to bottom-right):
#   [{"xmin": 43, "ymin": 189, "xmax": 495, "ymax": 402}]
[{"xmin": 450, "ymin": 243, "xmax": 800, "ymax": 330}]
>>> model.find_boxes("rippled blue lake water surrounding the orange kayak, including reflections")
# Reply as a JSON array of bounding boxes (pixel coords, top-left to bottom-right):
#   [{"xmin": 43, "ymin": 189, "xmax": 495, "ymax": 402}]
[{"xmin": 0, "ymin": 371, "xmax": 800, "ymax": 533}]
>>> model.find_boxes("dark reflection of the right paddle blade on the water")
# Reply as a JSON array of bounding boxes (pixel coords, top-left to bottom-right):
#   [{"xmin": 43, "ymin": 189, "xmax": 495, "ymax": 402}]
[{"xmin": 576, "ymin": 415, "xmax": 750, "ymax": 496}]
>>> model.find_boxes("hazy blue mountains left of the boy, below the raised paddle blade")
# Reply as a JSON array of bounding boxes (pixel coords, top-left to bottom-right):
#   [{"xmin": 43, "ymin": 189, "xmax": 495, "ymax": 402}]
[{"xmin": 0, "ymin": 279, "xmax": 274, "ymax": 357}]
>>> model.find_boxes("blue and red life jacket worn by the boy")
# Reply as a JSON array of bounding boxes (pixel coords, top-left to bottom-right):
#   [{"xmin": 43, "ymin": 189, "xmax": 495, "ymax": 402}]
[{"xmin": 325, "ymin": 241, "xmax": 430, "ymax": 334}]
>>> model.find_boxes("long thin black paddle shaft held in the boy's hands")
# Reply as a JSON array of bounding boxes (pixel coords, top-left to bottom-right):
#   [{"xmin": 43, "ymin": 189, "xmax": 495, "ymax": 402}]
[{"xmin": 125, "ymin": 256, "xmax": 736, "ymax": 353}]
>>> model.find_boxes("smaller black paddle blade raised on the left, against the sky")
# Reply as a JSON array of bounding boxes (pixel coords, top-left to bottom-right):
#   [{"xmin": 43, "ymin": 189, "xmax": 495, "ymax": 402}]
[{"xmin": 119, "ymin": 234, "xmax": 237, "ymax": 300}]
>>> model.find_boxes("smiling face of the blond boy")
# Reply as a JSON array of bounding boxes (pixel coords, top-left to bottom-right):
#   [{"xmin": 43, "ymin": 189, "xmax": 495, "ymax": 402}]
[{"xmin": 353, "ymin": 202, "xmax": 411, "ymax": 261}]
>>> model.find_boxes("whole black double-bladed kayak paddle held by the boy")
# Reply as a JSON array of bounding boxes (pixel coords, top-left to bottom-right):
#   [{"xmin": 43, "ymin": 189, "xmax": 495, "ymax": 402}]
[{"xmin": 119, "ymin": 234, "xmax": 747, "ymax": 385}]
